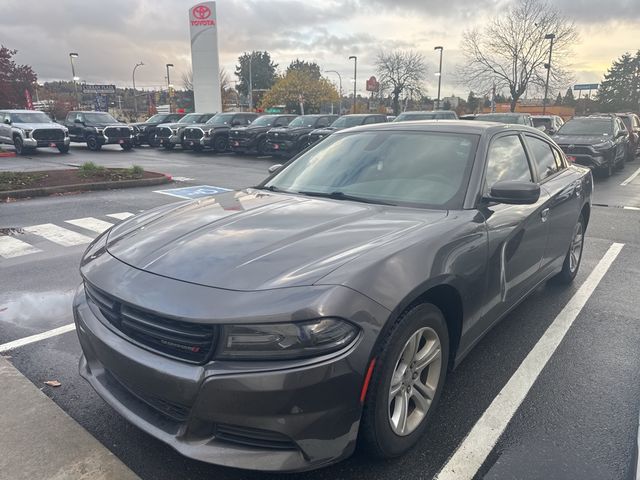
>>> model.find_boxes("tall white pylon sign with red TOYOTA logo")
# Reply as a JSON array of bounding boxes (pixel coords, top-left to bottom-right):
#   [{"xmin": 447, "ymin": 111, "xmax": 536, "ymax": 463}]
[{"xmin": 189, "ymin": 2, "xmax": 222, "ymax": 112}]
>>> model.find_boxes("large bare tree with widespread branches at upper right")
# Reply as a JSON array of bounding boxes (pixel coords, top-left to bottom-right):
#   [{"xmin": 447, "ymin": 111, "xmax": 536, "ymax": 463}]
[{"xmin": 459, "ymin": 0, "xmax": 578, "ymax": 112}]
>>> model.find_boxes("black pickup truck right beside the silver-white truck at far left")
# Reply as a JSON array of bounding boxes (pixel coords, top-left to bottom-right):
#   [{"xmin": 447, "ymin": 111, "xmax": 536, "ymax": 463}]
[{"xmin": 63, "ymin": 111, "xmax": 134, "ymax": 151}]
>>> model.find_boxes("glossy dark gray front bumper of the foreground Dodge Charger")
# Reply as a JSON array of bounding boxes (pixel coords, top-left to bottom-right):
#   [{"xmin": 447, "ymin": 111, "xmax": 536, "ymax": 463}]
[{"xmin": 73, "ymin": 270, "xmax": 388, "ymax": 471}]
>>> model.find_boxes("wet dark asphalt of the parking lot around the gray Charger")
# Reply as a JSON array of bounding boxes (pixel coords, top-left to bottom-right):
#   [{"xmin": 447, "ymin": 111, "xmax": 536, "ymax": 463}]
[{"xmin": 0, "ymin": 147, "xmax": 640, "ymax": 480}]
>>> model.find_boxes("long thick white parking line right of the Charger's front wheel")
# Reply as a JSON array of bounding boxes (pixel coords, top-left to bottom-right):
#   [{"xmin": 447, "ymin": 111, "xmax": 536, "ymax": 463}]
[{"xmin": 436, "ymin": 243, "xmax": 624, "ymax": 480}]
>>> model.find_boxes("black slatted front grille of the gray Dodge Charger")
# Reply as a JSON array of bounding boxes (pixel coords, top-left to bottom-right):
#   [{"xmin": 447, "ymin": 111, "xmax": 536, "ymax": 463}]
[{"xmin": 85, "ymin": 282, "xmax": 216, "ymax": 364}]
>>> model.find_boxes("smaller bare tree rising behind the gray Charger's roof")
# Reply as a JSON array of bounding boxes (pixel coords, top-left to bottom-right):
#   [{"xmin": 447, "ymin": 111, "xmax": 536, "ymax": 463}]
[{"xmin": 376, "ymin": 50, "xmax": 427, "ymax": 115}]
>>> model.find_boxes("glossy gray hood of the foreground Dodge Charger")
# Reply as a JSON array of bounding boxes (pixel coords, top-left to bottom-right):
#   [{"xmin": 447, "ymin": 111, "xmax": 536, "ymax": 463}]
[{"xmin": 107, "ymin": 189, "xmax": 447, "ymax": 291}]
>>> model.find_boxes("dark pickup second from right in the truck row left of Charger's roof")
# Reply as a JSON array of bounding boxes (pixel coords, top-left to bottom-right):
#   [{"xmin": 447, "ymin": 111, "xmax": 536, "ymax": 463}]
[{"xmin": 267, "ymin": 115, "xmax": 338, "ymax": 157}]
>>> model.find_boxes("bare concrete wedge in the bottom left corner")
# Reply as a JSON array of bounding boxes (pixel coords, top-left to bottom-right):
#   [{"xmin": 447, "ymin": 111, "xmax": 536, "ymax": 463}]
[{"xmin": 0, "ymin": 356, "xmax": 139, "ymax": 480}]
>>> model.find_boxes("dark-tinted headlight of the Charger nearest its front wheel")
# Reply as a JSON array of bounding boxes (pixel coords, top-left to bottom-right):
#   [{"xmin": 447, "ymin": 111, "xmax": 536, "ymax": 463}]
[{"xmin": 217, "ymin": 318, "xmax": 358, "ymax": 360}]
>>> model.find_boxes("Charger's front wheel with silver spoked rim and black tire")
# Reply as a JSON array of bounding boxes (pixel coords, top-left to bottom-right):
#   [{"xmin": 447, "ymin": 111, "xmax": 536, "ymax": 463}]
[{"xmin": 360, "ymin": 303, "xmax": 449, "ymax": 458}]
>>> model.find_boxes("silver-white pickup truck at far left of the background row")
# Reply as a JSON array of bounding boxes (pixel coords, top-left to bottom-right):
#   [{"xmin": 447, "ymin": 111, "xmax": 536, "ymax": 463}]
[{"xmin": 0, "ymin": 110, "xmax": 69, "ymax": 155}]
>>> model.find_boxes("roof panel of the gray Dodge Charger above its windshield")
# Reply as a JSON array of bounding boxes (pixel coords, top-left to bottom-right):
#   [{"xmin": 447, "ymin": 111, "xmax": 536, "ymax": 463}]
[{"xmin": 340, "ymin": 120, "xmax": 541, "ymax": 135}]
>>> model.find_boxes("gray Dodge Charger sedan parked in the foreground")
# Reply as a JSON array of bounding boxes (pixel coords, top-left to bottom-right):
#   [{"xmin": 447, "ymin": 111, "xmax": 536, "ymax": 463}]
[{"xmin": 73, "ymin": 121, "xmax": 592, "ymax": 471}]
